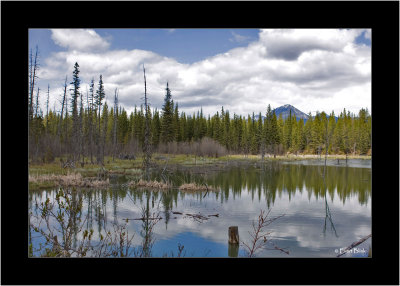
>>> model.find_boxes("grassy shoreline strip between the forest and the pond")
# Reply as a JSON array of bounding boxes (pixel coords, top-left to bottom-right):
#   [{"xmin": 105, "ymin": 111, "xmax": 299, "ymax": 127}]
[{"xmin": 28, "ymin": 154, "xmax": 371, "ymax": 190}]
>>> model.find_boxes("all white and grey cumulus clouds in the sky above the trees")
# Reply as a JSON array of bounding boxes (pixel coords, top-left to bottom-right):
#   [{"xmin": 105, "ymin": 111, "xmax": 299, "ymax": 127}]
[{"xmin": 39, "ymin": 29, "xmax": 371, "ymax": 118}]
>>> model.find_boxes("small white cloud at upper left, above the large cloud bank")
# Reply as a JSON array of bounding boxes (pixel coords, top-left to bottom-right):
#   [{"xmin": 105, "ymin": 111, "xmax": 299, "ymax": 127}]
[{"xmin": 51, "ymin": 29, "xmax": 110, "ymax": 51}]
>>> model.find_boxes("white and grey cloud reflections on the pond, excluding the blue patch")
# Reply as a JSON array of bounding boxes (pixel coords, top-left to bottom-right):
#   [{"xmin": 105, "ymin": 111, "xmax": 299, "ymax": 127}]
[{"xmin": 80, "ymin": 189, "xmax": 371, "ymax": 256}]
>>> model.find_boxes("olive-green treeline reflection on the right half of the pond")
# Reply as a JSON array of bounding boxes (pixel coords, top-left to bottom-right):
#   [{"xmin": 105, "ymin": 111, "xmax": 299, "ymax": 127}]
[{"xmin": 208, "ymin": 163, "xmax": 371, "ymax": 205}]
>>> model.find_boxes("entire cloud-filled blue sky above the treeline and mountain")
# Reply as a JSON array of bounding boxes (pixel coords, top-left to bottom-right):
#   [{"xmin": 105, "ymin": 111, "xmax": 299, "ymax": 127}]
[{"xmin": 29, "ymin": 29, "xmax": 371, "ymax": 115}]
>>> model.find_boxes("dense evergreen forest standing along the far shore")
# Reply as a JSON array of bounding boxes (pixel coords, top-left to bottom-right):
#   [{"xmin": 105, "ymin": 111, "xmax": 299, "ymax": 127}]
[{"xmin": 28, "ymin": 55, "xmax": 371, "ymax": 163}]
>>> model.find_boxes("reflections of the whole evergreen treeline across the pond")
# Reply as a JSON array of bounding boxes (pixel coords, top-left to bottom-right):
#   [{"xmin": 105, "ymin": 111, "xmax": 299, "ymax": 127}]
[{"xmin": 29, "ymin": 162, "xmax": 371, "ymax": 228}]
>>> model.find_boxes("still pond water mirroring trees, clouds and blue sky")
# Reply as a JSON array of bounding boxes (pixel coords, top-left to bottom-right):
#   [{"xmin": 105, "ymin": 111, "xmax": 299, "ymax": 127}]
[{"xmin": 29, "ymin": 163, "xmax": 371, "ymax": 257}]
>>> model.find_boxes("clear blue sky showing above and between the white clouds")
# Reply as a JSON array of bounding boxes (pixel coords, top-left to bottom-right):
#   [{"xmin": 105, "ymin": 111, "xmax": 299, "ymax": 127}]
[{"xmin": 29, "ymin": 29, "xmax": 259, "ymax": 64}]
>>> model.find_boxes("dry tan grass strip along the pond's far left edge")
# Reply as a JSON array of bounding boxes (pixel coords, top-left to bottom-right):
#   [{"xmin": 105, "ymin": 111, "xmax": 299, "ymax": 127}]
[{"xmin": 29, "ymin": 173, "xmax": 110, "ymax": 188}]
